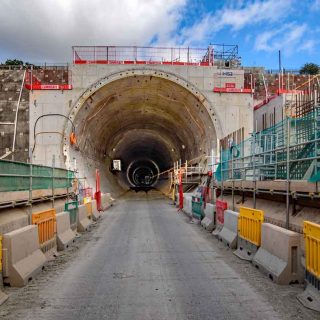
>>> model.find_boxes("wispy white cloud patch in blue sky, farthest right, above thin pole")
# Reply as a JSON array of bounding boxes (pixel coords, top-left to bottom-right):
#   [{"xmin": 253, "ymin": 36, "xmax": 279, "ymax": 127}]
[{"xmin": 255, "ymin": 23, "xmax": 315, "ymax": 55}]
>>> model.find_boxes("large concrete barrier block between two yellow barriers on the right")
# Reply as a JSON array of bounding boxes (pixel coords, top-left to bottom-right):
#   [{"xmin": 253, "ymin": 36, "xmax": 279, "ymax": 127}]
[{"xmin": 252, "ymin": 223, "xmax": 303, "ymax": 284}]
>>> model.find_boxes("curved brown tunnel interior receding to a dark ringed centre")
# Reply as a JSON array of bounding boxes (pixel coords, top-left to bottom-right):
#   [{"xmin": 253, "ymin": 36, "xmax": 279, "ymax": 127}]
[{"xmin": 74, "ymin": 75, "xmax": 216, "ymax": 195}]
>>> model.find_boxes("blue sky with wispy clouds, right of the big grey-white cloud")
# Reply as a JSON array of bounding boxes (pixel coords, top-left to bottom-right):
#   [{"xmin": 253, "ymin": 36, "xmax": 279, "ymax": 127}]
[{"xmin": 175, "ymin": 0, "xmax": 320, "ymax": 68}]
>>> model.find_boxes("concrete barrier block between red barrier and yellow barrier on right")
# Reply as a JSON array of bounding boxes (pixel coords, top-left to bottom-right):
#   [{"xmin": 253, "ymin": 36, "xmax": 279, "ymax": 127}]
[{"xmin": 218, "ymin": 210, "xmax": 239, "ymax": 249}]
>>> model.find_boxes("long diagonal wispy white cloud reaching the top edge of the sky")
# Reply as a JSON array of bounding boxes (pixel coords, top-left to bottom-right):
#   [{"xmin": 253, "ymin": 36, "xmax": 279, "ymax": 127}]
[{"xmin": 181, "ymin": 0, "xmax": 293, "ymax": 44}]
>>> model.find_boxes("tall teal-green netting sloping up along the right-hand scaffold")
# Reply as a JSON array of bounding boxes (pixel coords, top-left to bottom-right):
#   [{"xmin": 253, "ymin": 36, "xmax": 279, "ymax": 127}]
[{"xmin": 216, "ymin": 107, "xmax": 320, "ymax": 182}]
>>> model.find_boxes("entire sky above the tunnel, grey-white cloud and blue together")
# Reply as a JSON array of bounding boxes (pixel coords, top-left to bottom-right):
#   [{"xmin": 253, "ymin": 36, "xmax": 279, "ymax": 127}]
[{"xmin": 0, "ymin": 0, "xmax": 320, "ymax": 69}]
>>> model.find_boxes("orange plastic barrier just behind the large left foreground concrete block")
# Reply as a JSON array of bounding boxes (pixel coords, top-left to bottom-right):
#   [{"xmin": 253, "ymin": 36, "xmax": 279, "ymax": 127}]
[{"xmin": 32, "ymin": 209, "xmax": 56, "ymax": 246}]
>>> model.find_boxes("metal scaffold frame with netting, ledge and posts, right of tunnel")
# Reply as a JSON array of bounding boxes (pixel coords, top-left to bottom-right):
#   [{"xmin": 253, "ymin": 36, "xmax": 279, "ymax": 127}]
[{"xmin": 215, "ymin": 92, "xmax": 320, "ymax": 229}]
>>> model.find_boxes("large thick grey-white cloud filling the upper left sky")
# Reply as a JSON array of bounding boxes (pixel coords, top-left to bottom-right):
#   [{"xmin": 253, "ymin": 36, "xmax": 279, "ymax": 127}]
[{"xmin": 0, "ymin": 0, "xmax": 187, "ymax": 62}]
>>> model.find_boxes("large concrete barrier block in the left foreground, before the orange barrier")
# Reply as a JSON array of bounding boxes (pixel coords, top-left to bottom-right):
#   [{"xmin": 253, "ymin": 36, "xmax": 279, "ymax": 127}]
[{"xmin": 3, "ymin": 225, "xmax": 47, "ymax": 287}]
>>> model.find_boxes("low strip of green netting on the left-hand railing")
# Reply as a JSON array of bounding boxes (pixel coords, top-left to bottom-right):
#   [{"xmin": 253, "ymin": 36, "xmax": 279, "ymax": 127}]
[{"xmin": 0, "ymin": 160, "xmax": 74, "ymax": 192}]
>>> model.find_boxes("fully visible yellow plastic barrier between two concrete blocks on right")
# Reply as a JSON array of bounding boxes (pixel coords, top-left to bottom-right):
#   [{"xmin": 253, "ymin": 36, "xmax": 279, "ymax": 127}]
[{"xmin": 238, "ymin": 207, "xmax": 264, "ymax": 247}]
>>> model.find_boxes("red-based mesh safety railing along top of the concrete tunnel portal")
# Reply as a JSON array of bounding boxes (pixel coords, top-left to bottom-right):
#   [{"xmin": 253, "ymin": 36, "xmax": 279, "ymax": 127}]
[{"xmin": 73, "ymin": 46, "xmax": 215, "ymax": 66}]
